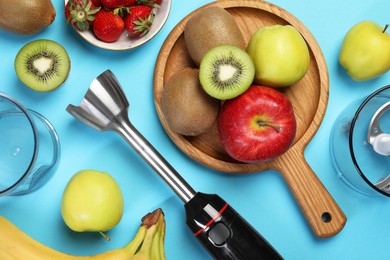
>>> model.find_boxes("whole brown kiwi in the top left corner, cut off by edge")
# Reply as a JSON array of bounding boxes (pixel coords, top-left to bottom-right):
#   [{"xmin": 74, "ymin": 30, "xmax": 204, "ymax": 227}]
[{"xmin": 0, "ymin": 0, "xmax": 56, "ymax": 35}]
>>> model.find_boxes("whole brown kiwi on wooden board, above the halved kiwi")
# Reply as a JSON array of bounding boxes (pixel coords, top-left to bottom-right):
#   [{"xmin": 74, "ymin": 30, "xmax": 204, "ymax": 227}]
[{"xmin": 184, "ymin": 6, "xmax": 246, "ymax": 66}]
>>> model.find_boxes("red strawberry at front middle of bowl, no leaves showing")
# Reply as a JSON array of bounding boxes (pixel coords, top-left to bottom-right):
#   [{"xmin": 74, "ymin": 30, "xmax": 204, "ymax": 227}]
[{"xmin": 93, "ymin": 9, "xmax": 125, "ymax": 42}]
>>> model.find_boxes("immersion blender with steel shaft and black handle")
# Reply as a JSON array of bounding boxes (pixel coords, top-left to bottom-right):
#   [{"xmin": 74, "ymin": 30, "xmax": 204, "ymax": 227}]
[{"xmin": 66, "ymin": 70, "xmax": 282, "ymax": 260}]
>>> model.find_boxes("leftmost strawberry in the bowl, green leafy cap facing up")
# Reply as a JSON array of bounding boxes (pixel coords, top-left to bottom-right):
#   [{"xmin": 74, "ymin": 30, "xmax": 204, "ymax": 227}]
[{"xmin": 65, "ymin": 0, "xmax": 100, "ymax": 31}]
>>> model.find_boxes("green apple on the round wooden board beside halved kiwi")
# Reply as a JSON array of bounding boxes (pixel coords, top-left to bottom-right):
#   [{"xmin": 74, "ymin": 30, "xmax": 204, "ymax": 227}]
[{"xmin": 247, "ymin": 24, "xmax": 310, "ymax": 87}]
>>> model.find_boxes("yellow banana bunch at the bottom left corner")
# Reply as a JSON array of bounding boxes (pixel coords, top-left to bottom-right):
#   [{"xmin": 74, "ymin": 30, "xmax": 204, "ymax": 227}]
[{"xmin": 0, "ymin": 209, "xmax": 165, "ymax": 260}]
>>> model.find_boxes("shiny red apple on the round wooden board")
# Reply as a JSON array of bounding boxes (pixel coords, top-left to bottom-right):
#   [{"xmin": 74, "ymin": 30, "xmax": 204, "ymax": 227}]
[{"xmin": 217, "ymin": 85, "xmax": 296, "ymax": 163}]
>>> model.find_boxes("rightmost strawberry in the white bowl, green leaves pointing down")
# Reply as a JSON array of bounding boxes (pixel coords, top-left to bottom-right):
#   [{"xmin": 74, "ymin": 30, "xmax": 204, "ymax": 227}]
[{"xmin": 125, "ymin": 5, "xmax": 154, "ymax": 38}]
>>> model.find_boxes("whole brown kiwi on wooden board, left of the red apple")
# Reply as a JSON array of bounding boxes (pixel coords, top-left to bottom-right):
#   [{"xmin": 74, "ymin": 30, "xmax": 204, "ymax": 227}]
[{"xmin": 161, "ymin": 68, "xmax": 220, "ymax": 136}]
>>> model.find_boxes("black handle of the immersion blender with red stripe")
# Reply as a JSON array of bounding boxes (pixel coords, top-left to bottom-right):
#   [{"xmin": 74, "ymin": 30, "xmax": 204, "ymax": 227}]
[{"xmin": 185, "ymin": 192, "xmax": 283, "ymax": 260}]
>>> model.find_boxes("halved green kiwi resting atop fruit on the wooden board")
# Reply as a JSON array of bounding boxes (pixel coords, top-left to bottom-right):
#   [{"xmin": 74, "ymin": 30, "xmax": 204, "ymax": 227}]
[{"xmin": 199, "ymin": 45, "xmax": 255, "ymax": 100}]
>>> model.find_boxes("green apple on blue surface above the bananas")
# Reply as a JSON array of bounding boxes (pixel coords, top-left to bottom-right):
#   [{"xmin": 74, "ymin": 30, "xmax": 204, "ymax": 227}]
[{"xmin": 61, "ymin": 170, "xmax": 124, "ymax": 237}]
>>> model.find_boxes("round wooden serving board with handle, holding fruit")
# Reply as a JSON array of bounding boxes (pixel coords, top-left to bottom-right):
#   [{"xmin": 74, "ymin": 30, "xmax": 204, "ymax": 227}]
[{"xmin": 154, "ymin": 0, "xmax": 346, "ymax": 237}]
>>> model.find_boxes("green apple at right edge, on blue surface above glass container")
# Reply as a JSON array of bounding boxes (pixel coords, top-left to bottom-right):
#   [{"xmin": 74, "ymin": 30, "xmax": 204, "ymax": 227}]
[{"xmin": 339, "ymin": 21, "xmax": 390, "ymax": 81}]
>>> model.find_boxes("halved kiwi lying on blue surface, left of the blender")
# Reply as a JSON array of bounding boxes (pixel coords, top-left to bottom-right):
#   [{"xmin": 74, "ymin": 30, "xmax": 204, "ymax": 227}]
[{"xmin": 14, "ymin": 39, "xmax": 70, "ymax": 92}]
